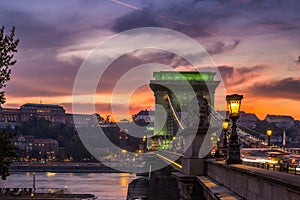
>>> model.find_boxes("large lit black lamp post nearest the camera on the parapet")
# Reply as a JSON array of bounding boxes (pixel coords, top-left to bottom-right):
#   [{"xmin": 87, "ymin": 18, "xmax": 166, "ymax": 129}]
[{"xmin": 226, "ymin": 94, "xmax": 243, "ymax": 164}]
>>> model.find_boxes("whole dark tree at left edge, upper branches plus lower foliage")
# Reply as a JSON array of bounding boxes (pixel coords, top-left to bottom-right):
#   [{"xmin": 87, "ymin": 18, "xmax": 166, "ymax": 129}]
[{"xmin": 0, "ymin": 26, "xmax": 19, "ymax": 180}]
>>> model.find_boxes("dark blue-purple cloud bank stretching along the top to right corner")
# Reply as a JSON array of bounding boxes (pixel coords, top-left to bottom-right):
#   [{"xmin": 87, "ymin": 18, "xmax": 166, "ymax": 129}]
[{"xmin": 113, "ymin": 0, "xmax": 300, "ymax": 37}]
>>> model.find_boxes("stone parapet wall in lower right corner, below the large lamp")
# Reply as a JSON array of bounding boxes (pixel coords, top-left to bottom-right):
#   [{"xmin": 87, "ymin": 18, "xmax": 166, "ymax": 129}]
[{"xmin": 206, "ymin": 160, "xmax": 300, "ymax": 200}]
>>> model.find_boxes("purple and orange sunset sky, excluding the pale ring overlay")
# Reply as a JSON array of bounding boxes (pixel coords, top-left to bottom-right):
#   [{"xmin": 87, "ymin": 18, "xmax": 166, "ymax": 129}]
[{"xmin": 0, "ymin": 0, "xmax": 300, "ymax": 119}]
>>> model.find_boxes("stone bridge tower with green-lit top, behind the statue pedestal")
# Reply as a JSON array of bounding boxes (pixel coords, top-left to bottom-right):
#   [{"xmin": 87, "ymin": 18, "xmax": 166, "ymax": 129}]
[{"xmin": 150, "ymin": 71, "xmax": 220, "ymax": 150}]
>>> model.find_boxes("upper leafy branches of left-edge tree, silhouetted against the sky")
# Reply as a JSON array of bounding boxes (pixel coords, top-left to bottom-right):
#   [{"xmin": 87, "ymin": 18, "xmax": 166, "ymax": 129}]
[{"xmin": 0, "ymin": 26, "xmax": 19, "ymax": 104}]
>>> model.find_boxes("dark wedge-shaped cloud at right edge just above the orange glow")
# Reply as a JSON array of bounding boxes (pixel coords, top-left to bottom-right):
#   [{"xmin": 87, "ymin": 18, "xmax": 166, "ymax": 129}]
[{"xmin": 249, "ymin": 77, "xmax": 300, "ymax": 100}]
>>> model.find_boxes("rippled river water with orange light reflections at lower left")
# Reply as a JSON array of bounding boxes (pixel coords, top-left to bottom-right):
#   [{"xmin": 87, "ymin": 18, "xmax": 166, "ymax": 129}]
[{"xmin": 0, "ymin": 172, "xmax": 136, "ymax": 200}]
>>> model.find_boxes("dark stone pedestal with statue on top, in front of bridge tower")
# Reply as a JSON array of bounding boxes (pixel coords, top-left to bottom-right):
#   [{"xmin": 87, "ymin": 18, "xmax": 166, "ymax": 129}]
[{"xmin": 172, "ymin": 97, "xmax": 210, "ymax": 200}]
